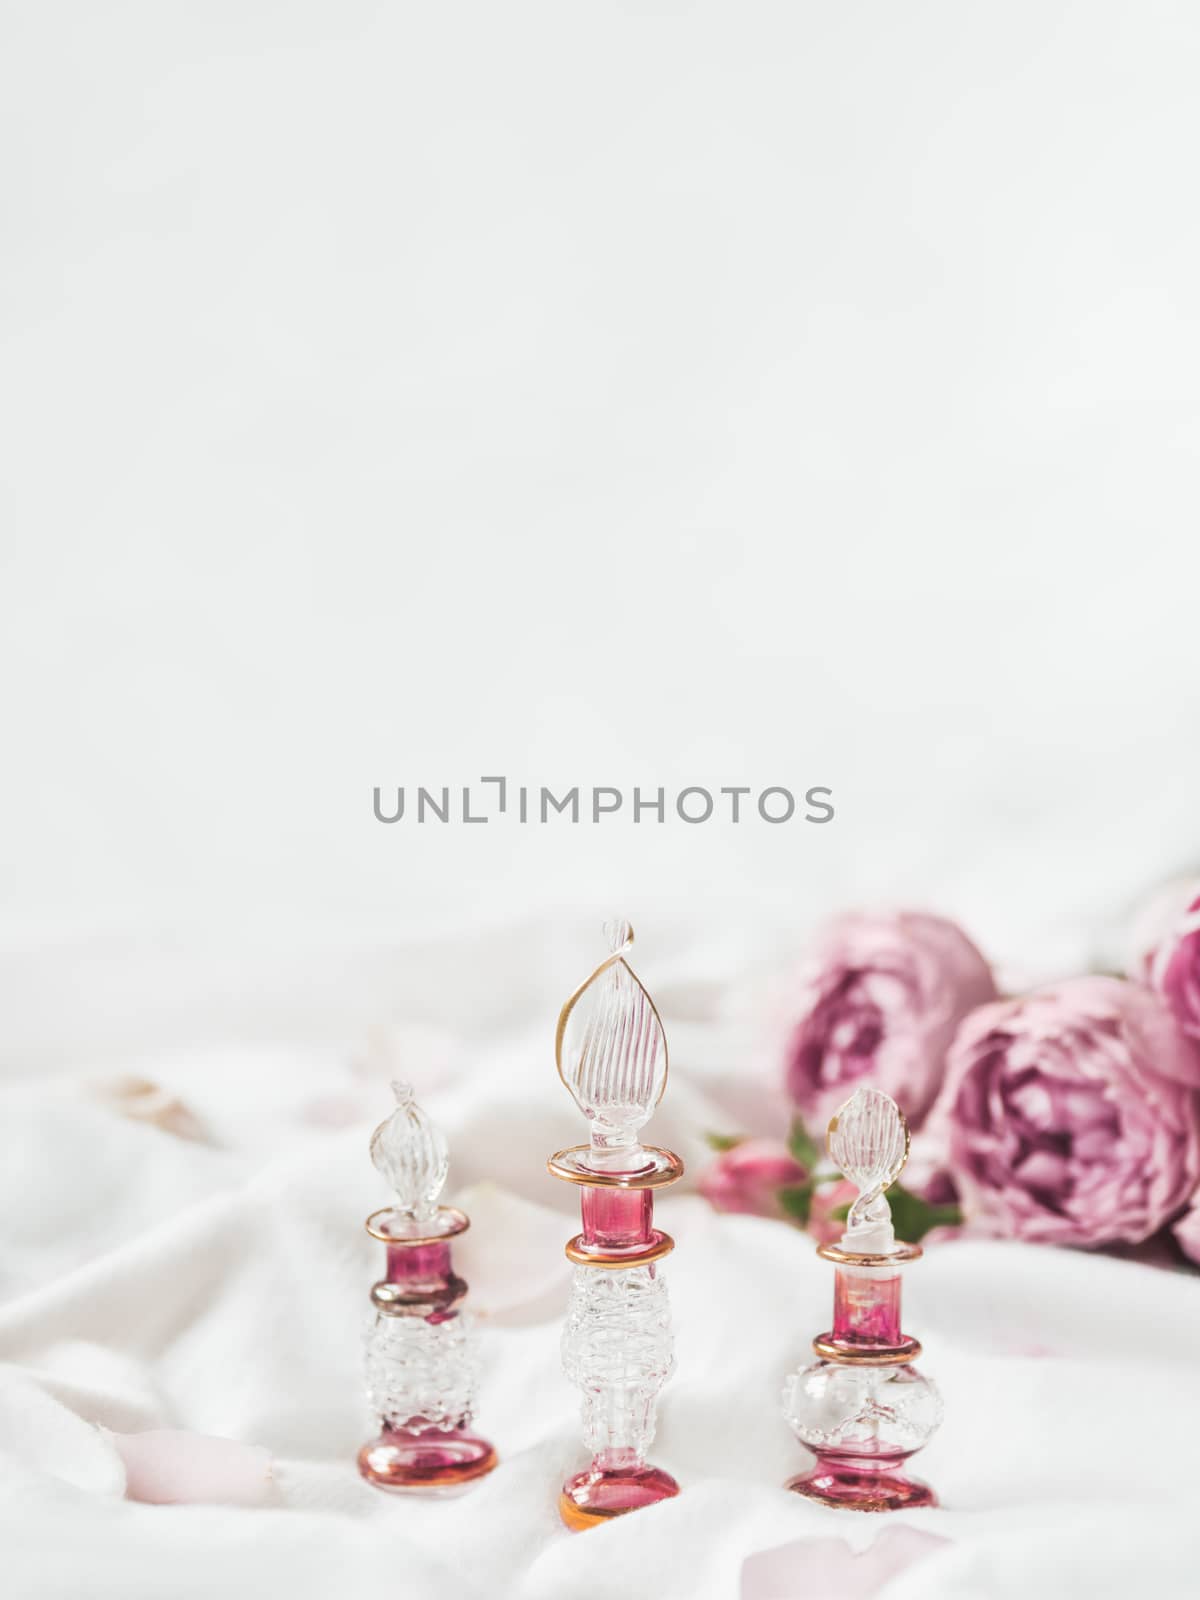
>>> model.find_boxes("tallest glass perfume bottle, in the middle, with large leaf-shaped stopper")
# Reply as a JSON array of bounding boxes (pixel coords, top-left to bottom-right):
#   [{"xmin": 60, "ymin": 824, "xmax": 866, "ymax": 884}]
[{"xmin": 547, "ymin": 922, "xmax": 683, "ymax": 1528}]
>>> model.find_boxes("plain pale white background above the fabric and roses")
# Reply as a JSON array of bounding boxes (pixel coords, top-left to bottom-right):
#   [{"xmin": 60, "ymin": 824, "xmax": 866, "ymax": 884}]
[{"xmin": 0, "ymin": 0, "xmax": 1200, "ymax": 1037}]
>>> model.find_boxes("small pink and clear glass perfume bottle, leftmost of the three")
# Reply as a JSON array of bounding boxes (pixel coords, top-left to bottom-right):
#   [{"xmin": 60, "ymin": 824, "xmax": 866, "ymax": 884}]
[{"xmin": 358, "ymin": 1083, "xmax": 496, "ymax": 1491}]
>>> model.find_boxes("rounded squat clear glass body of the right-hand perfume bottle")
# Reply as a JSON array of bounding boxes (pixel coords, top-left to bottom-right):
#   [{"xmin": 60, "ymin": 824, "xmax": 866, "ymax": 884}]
[{"xmin": 784, "ymin": 1362, "xmax": 942, "ymax": 1466}]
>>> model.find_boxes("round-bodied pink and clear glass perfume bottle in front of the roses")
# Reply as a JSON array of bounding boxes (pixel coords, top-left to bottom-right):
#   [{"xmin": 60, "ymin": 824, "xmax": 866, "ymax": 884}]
[{"xmin": 784, "ymin": 1088, "xmax": 942, "ymax": 1510}]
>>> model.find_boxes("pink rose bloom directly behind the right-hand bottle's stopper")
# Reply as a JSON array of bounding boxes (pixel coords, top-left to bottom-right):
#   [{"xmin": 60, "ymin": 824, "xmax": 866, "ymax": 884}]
[{"xmin": 787, "ymin": 912, "xmax": 997, "ymax": 1128}]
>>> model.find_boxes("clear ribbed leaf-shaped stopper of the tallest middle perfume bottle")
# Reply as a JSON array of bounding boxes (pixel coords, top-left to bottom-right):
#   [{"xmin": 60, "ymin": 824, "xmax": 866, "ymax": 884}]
[{"xmin": 555, "ymin": 918, "xmax": 667, "ymax": 1171}]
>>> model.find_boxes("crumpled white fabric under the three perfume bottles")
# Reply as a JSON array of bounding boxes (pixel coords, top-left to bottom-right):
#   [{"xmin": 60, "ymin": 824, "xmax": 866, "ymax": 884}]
[{"xmin": 0, "ymin": 934, "xmax": 1200, "ymax": 1600}]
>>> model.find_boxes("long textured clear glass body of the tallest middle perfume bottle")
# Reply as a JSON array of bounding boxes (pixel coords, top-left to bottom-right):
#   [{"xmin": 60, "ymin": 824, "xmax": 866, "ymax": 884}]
[{"xmin": 562, "ymin": 1264, "xmax": 675, "ymax": 1469}]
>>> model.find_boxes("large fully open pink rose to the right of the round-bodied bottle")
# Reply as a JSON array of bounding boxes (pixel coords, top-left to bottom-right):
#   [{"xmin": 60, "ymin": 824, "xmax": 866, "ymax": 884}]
[{"xmin": 938, "ymin": 978, "xmax": 1200, "ymax": 1245}]
